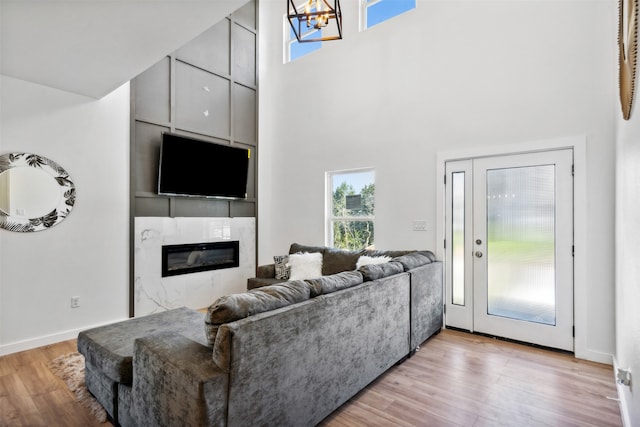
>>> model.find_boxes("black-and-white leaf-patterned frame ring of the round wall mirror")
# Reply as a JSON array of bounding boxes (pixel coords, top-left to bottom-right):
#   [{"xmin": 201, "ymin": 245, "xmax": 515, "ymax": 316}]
[{"xmin": 0, "ymin": 153, "xmax": 76, "ymax": 233}]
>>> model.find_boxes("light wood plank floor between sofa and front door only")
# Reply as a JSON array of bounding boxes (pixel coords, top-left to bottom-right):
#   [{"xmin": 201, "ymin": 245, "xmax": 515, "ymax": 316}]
[{"xmin": 323, "ymin": 330, "xmax": 622, "ymax": 427}]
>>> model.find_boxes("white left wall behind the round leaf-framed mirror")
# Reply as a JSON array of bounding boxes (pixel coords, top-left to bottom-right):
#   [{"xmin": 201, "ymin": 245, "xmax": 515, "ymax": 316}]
[{"xmin": 0, "ymin": 76, "xmax": 129, "ymax": 355}]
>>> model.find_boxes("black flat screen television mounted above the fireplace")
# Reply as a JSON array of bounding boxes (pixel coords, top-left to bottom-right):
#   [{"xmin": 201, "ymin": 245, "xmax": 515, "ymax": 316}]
[{"xmin": 158, "ymin": 132, "xmax": 251, "ymax": 199}]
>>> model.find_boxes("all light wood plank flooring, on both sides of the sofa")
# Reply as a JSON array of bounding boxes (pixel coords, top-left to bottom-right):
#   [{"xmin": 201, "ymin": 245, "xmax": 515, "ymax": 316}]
[{"xmin": 0, "ymin": 330, "xmax": 622, "ymax": 427}]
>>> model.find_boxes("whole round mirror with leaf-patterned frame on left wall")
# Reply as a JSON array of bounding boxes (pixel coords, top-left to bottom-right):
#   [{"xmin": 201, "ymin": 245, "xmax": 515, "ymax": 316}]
[{"xmin": 0, "ymin": 153, "xmax": 76, "ymax": 232}]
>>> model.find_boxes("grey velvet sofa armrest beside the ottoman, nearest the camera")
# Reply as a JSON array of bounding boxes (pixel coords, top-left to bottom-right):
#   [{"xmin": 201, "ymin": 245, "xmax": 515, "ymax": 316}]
[{"xmin": 132, "ymin": 332, "xmax": 229, "ymax": 426}]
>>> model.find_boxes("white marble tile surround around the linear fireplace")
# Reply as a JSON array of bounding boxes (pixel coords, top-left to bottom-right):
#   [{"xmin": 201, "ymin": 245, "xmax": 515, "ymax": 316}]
[{"xmin": 133, "ymin": 217, "xmax": 256, "ymax": 317}]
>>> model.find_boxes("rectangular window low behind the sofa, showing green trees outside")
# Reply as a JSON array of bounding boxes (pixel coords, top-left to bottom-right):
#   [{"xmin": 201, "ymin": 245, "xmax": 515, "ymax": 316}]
[{"xmin": 327, "ymin": 169, "xmax": 375, "ymax": 249}]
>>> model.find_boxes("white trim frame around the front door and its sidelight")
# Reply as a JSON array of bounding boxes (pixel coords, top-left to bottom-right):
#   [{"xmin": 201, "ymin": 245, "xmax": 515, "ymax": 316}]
[{"xmin": 435, "ymin": 136, "xmax": 592, "ymax": 356}]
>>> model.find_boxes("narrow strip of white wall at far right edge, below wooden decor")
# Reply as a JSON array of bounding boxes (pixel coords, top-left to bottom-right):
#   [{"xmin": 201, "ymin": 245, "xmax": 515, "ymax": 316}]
[{"xmin": 615, "ymin": 106, "xmax": 640, "ymax": 426}]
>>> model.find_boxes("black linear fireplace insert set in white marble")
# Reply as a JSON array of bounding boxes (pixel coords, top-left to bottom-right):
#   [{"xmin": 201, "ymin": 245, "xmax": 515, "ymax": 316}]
[{"xmin": 162, "ymin": 240, "xmax": 240, "ymax": 277}]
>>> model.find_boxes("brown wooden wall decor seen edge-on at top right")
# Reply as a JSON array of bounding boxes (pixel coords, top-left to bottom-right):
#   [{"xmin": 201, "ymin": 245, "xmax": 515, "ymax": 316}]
[{"xmin": 618, "ymin": 0, "xmax": 638, "ymax": 120}]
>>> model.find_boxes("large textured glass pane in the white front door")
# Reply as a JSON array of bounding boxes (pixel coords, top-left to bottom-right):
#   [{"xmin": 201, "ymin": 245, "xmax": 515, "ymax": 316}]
[{"xmin": 486, "ymin": 165, "xmax": 556, "ymax": 325}]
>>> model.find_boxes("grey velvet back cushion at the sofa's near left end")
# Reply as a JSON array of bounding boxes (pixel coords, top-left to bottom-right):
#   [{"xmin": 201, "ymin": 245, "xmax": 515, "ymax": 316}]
[{"xmin": 204, "ymin": 280, "xmax": 311, "ymax": 345}]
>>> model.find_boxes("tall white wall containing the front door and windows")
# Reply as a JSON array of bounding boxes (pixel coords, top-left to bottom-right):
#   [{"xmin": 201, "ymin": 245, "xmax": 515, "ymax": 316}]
[{"xmin": 258, "ymin": 0, "xmax": 617, "ymax": 361}]
